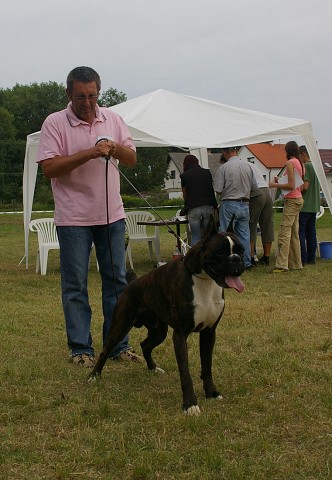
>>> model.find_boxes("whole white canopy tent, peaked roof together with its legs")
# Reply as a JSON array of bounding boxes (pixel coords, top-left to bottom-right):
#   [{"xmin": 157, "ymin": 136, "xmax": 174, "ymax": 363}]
[{"xmin": 23, "ymin": 90, "xmax": 332, "ymax": 268}]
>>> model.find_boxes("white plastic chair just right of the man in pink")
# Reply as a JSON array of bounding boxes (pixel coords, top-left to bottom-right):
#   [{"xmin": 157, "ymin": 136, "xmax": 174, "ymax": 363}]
[{"xmin": 126, "ymin": 211, "xmax": 161, "ymax": 270}]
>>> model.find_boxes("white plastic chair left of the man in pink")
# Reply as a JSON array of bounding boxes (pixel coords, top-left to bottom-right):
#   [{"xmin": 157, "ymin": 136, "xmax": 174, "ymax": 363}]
[{"xmin": 29, "ymin": 218, "xmax": 60, "ymax": 275}]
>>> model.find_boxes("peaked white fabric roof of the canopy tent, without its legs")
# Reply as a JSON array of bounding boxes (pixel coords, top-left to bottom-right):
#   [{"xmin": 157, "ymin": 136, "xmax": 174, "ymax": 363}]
[{"xmin": 111, "ymin": 89, "xmax": 312, "ymax": 149}]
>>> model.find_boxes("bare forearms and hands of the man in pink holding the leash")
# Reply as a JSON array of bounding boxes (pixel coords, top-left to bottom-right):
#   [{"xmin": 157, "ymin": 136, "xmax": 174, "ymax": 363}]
[{"xmin": 41, "ymin": 141, "xmax": 136, "ymax": 178}]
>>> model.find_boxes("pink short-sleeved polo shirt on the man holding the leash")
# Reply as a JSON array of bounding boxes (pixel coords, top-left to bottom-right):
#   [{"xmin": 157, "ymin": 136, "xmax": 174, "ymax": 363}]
[{"xmin": 37, "ymin": 103, "xmax": 136, "ymax": 226}]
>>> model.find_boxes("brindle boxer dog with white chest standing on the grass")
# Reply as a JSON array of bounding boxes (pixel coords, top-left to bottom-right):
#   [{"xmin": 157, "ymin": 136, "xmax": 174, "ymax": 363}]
[{"xmin": 89, "ymin": 218, "xmax": 244, "ymax": 415}]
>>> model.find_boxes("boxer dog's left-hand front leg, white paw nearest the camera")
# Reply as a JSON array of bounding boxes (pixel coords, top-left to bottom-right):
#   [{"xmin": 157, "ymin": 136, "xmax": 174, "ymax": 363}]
[{"xmin": 173, "ymin": 330, "xmax": 200, "ymax": 415}]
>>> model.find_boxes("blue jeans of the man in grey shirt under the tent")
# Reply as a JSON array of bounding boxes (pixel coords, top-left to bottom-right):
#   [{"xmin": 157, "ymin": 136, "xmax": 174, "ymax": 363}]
[{"xmin": 219, "ymin": 200, "xmax": 251, "ymax": 267}]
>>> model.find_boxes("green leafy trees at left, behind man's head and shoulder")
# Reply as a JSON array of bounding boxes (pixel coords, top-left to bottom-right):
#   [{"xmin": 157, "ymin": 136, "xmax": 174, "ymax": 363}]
[{"xmin": 0, "ymin": 82, "xmax": 126, "ymax": 203}]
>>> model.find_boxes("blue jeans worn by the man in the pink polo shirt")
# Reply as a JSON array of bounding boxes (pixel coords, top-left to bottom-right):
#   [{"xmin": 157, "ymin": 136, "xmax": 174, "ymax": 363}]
[{"xmin": 57, "ymin": 220, "xmax": 130, "ymax": 357}]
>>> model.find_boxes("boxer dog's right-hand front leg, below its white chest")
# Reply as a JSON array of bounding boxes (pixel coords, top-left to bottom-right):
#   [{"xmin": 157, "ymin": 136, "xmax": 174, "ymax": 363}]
[{"xmin": 199, "ymin": 328, "xmax": 222, "ymax": 400}]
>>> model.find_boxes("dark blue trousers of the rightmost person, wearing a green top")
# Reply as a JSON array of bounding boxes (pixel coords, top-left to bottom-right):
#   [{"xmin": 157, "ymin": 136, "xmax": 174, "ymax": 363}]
[{"xmin": 299, "ymin": 212, "xmax": 317, "ymax": 265}]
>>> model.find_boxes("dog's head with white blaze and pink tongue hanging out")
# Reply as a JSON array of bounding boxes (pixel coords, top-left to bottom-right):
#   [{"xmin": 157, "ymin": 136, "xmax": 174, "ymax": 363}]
[{"xmin": 184, "ymin": 216, "xmax": 244, "ymax": 292}]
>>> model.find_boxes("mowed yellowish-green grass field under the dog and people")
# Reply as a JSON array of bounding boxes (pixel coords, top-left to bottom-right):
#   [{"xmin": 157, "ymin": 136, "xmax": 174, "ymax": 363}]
[{"xmin": 0, "ymin": 211, "xmax": 332, "ymax": 480}]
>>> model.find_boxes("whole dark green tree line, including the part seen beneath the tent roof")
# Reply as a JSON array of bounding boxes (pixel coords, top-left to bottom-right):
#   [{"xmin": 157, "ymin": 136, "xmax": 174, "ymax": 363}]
[{"xmin": 0, "ymin": 82, "xmax": 168, "ymax": 207}]
